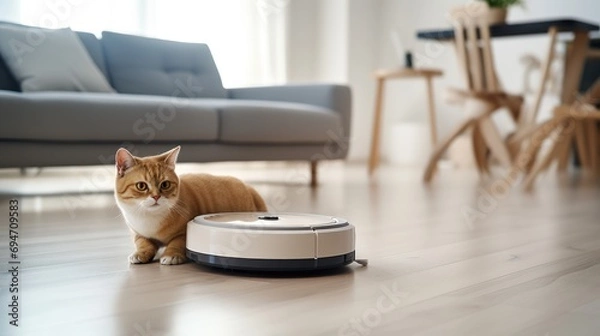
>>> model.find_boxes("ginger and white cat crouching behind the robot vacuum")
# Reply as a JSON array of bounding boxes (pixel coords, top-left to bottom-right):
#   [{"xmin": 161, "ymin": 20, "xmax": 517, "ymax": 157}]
[{"xmin": 115, "ymin": 146, "xmax": 267, "ymax": 265}]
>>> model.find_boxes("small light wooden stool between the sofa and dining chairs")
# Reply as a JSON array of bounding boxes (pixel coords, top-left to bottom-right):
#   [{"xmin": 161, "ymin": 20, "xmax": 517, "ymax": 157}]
[{"xmin": 369, "ymin": 68, "xmax": 443, "ymax": 175}]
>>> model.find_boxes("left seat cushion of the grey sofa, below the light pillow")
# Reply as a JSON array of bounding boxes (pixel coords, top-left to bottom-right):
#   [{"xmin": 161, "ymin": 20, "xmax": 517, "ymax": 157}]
[{"xmin": 0, "ymin": 91, "xmax": 219, "ymax": 143}]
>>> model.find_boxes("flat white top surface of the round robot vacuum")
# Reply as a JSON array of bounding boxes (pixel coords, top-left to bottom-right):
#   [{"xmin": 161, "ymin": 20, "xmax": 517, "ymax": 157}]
[{"xmin": 193, "ymin": 212, "xmax": 349, "ymax": 231}]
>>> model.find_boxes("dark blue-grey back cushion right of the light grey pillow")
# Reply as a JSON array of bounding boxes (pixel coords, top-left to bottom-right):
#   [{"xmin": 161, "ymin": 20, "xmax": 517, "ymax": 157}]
[{"xmin": 102, "ymin": 32, "xmax": 227, "ymax": 98}]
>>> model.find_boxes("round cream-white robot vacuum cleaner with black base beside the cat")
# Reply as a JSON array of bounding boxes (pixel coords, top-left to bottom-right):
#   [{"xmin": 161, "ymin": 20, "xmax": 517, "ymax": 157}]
[{"xmin": 186, "ymin": 212, "xmax": 355, "ymax": 271}]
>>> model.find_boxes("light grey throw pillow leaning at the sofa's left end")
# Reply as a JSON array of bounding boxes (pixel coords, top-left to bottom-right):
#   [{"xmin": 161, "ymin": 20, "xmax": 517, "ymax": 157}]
[{"xmin": 0, "ymin": 25, "xmax": 114, "ymax": 92}]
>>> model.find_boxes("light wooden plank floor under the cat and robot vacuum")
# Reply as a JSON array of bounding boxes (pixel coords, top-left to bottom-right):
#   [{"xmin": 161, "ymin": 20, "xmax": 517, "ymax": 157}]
[{"xmin": 0, "ymin": 163, "xmax": 600, "ymax": 336}]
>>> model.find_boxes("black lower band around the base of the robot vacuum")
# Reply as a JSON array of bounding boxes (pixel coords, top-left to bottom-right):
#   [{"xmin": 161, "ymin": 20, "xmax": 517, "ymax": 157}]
[{"xmin": 186, "ymin": 249, "xmax": 354, "ymax": 272}]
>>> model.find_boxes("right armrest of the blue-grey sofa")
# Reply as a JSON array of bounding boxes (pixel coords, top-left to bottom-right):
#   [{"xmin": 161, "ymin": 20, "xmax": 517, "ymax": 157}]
[{"xmin": 227, "ymin": 84, "xmax": 352, "ymax": 142}]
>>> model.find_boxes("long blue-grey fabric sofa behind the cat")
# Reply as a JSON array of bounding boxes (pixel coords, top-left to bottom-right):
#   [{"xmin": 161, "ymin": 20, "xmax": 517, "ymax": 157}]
[{"xmin": 0, "ymin": 26, "xmax": 351, "ymax": 184}]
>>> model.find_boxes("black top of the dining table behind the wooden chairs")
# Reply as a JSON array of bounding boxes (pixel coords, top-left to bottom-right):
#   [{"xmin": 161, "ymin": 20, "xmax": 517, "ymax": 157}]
[{"xmin": 417, "ymin": 18, "xmax": 600, "ymax": 40}]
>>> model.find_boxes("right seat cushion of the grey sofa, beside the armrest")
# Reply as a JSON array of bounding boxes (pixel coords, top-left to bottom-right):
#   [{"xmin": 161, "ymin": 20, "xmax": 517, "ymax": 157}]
[{"xmin": 195, "ymin": 99, "xmax": 342, "ymax": 144}]
